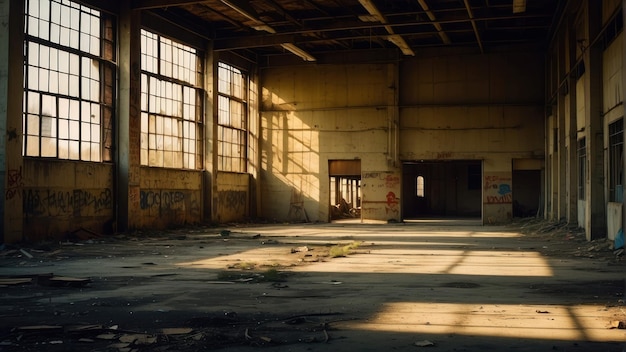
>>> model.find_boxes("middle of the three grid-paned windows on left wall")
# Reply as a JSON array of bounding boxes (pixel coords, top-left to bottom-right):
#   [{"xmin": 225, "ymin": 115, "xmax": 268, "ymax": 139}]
[{"xmin": 141, "ymin": 30, "xmax": 203, "ymax": 169}]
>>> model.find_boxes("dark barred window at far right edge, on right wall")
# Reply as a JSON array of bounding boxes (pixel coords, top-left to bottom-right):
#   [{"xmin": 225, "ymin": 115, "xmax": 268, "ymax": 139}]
[{"xmin": 609, "ymin": 119, "xmax": 624, "ymax": 202}]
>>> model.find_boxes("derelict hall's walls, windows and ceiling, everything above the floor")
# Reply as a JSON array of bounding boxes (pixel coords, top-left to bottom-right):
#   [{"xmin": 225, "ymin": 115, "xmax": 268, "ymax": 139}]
[{"xmin": 0, "ymin": 0, "xmax": 624, "ymax": 243}]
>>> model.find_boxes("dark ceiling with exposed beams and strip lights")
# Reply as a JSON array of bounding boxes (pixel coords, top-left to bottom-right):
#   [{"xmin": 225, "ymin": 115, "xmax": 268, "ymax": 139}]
[{"xmin": 132, "ymin": 0, "xmax": 566, "ymax": 61}]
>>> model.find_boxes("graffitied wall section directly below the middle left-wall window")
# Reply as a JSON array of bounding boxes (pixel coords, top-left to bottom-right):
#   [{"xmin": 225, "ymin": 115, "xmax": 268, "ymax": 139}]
[{"xmin": 139, "ymin": 167, "xmax": 202, "ymax": 228}]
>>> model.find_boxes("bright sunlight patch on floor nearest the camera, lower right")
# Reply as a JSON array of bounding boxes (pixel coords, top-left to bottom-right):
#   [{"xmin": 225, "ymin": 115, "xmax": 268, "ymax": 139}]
[{"xmin": 344, "ymin": 302, "xmax": 626, "ymax": 341}]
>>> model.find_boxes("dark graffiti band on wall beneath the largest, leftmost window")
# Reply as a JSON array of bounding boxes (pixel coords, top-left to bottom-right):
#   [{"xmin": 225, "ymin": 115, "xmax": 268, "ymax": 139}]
[{"xmin": 22, "ymin": 188, "xmax": 113, "ymax": 217}]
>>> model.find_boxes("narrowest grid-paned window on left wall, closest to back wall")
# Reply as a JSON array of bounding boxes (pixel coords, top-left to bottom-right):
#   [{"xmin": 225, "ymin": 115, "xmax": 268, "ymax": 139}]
[{"xmin": 217, "ymin": 62, "xmax": 248, "ymax": 172}]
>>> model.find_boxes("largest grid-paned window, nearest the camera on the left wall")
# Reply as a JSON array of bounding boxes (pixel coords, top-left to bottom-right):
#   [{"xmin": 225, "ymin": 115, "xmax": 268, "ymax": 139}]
[{"xmin": 22, "ymin": 0, "xmax": 116, "ymax": 161}]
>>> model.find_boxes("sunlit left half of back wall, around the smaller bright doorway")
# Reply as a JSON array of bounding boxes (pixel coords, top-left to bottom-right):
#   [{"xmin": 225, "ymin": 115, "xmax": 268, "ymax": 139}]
[{"xmin": 260, "ymin": 64, "xmax": 392, "ymax": 221}]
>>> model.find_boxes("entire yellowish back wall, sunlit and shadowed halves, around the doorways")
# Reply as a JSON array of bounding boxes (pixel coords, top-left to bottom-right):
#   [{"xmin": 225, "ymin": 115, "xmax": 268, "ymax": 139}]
[{"xmin": 261, "ymin": 47, "xmax": 544, "ymax": 222}]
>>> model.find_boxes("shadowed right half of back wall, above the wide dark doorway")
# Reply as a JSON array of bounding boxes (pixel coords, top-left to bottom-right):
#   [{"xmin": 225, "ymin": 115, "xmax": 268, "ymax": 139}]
[{"xmin": 400, "ymin": 48, "xmax": 545, "ymax": 222}]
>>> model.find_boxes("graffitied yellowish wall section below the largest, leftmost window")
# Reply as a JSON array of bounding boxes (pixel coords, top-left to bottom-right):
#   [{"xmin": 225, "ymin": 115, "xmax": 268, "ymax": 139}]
[{"xmin": 22, "ymin": 158, "xmax": 115, "ymax": 241}]
